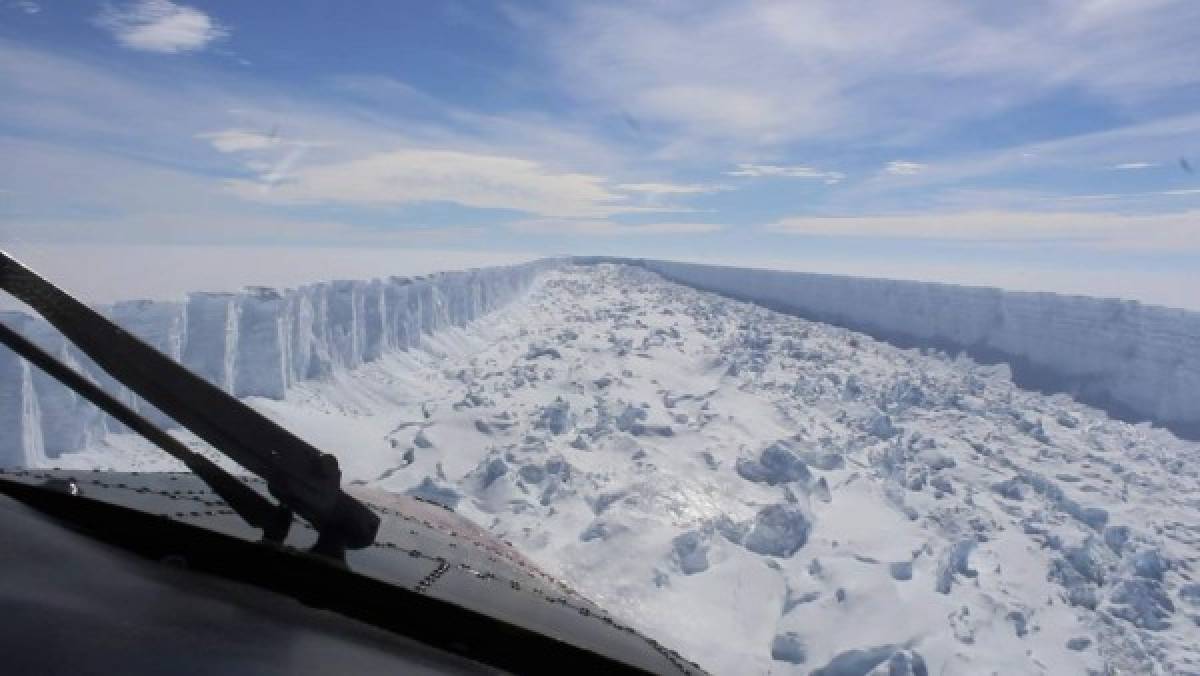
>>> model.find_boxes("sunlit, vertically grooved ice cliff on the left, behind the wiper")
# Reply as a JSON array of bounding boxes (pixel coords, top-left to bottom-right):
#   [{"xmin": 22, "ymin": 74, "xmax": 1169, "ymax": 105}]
[{"xmin": 0, "ymin": 259, "xmax": 559, "ymax": 467}]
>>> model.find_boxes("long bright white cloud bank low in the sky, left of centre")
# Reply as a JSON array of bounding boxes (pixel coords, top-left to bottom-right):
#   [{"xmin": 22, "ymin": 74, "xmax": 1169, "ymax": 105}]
[{"xmin": 228, "ymin": 148, "xmax": 679, "ymax": 219}]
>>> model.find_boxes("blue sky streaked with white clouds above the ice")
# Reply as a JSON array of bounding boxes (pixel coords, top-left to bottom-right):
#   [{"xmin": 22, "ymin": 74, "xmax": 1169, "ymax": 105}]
[{"xmin": 0, "ymin": 0, "xmax": 1200, "ymax": 309}]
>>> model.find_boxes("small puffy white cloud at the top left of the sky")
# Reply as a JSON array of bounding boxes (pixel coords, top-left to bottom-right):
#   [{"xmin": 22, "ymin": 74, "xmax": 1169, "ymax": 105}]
[{"xmin": 96, "ymin": 0, "xmax": 229, "ymax": 54}]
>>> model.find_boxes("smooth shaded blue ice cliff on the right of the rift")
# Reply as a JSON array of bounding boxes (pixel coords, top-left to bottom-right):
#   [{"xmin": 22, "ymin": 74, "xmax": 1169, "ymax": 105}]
[{"xmin": 614, "ymin": 261, "xmax": 1200, "ymax": 438}]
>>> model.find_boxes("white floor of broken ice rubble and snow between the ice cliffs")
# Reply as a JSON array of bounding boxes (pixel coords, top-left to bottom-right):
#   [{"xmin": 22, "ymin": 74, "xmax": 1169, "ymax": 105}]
[{"xmin": 16, "ymin": 264, "xmax": 1200, "ymax": 676}]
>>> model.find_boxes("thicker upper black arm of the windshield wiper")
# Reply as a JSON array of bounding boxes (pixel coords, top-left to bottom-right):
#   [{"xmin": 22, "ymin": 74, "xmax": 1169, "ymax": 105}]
[{"xmin": 0, "ymin": 251, "xmax": 379, "ymax": 558}]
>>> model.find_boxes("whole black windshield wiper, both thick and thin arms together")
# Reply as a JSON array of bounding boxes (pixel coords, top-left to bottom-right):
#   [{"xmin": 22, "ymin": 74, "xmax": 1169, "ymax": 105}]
[{"xmin": 0, "ymin": 251, "xmax": 379, "ymax": 560}]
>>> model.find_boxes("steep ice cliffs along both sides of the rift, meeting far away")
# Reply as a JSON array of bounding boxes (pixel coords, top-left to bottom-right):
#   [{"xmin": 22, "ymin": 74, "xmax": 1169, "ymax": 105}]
[{"xmin": 0, "ymin": 258, "xmax": 1200, "ymax": 466}]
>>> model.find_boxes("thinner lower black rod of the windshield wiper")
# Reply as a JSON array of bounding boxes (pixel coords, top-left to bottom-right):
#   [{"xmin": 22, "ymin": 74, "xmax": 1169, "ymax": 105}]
[{"xmin": 0, "ymin": 324, "xmax": 292, "ymax": 543}]
